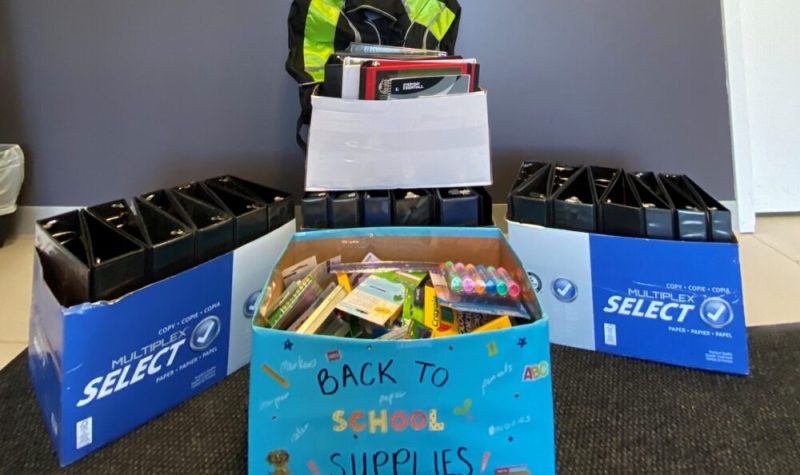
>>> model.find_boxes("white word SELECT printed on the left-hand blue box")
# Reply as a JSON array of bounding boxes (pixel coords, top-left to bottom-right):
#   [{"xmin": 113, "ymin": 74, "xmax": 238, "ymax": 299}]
[{"xmin": 77, "ymin": 339, "xmax": 186, "ymax": 407}]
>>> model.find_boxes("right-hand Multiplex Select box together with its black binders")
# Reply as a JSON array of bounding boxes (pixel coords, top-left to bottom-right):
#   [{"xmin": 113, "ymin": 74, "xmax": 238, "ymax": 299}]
[{"xmin": 508, "ymin": 161, "xmax": 749, "ymax": 374}]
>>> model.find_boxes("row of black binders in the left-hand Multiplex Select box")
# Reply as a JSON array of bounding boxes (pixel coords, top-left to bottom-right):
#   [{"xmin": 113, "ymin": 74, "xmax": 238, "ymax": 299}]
[{"xmin": 36, "ymin": 176, "xmax": 294, "ymax": 306}]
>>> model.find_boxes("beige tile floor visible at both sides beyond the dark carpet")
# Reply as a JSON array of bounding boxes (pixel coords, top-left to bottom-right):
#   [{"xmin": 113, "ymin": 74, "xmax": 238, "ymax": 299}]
[{"xmin": 0, "ymin": 214, "xmax": 800, "ymax": 368}]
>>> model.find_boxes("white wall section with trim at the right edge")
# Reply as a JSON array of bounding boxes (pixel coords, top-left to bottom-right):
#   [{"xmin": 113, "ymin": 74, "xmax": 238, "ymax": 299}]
[{"xmin": 723, "ymin": 0, "xmax": 800, "ymax": 212}]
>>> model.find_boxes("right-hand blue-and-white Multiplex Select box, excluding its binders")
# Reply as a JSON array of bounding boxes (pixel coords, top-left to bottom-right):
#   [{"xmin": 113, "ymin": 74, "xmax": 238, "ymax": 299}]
[{"xmin": 508, "ymin": 221, "xmax": 749, "ymax": 375}]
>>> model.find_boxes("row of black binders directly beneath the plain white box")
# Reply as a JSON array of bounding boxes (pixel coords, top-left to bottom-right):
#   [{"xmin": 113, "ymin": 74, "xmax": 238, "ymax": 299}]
[{"xmin": 300, "ymin": 187, "xmax": 492, "ymax": 229}]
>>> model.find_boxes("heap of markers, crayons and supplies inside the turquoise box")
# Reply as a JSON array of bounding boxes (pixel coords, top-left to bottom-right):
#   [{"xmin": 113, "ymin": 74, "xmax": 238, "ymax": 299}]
[{"xmin": 258, "ymin": 254, "xmax": 538, "ymax": 340}]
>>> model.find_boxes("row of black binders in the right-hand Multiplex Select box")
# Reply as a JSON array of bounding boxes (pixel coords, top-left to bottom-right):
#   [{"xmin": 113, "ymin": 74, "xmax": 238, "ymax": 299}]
[{"xmin": 508, "ymin": 161, "xmax": 734, "ymax": 242}]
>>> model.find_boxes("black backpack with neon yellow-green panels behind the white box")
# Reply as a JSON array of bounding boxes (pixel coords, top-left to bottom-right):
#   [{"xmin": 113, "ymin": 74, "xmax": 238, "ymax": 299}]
[{"xmin": 286, "ymin": 0, "xmax": 461, "ymax": 150}]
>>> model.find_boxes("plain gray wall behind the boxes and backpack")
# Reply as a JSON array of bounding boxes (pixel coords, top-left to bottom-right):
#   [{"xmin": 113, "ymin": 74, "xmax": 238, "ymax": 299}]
[{"xmin": 0, "ymin": 0, "xmax": 733, "ymax": 205}]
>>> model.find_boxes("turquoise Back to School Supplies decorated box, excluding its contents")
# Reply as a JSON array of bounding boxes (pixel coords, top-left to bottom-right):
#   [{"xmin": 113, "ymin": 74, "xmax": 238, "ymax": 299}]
[{"xmin": 248, "ymin": 228, "xmax": 555, "ymax": 475}]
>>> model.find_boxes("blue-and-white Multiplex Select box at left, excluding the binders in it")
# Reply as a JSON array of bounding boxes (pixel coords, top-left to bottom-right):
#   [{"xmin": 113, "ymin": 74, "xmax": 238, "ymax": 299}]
[{"xmin": 28, "ymin": 220, "xmax": 296, "ymax": 465}]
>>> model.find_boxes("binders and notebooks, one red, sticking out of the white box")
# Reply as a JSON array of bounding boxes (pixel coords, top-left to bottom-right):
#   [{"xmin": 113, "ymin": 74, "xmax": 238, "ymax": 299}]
[{"xmin": 321, "ymin": 43, "xmax": 480, "ymax": 100}]
